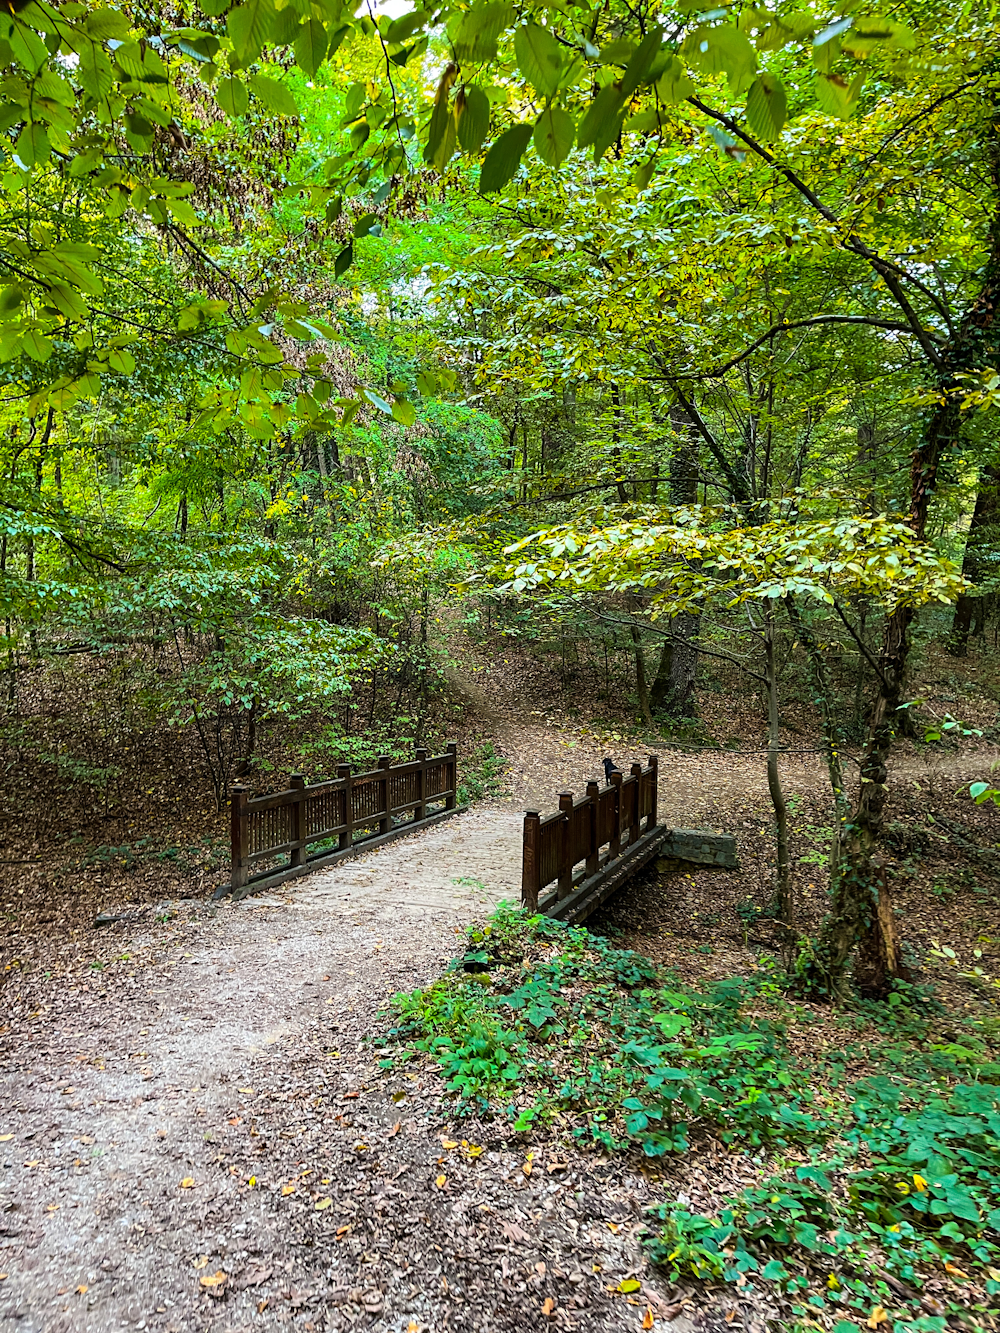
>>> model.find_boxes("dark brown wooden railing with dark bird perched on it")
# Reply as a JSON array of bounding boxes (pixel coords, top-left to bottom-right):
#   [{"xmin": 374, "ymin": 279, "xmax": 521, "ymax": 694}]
[{"xmin": 521, "ymin": 754, "xmax": 659, "ymax": 912}]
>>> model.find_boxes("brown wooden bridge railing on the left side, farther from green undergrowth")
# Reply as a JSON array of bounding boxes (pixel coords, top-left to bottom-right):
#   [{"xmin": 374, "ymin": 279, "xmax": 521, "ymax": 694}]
[{"xmin": 229, "ymin": 744, "xmax": 459, "ymax": 894}]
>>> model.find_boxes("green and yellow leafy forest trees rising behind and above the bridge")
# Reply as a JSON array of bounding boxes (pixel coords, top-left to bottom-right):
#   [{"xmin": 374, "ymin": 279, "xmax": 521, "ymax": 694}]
[{"xmin": 0, "ymin": 0, "xmax": 1000, "ymax": 993}]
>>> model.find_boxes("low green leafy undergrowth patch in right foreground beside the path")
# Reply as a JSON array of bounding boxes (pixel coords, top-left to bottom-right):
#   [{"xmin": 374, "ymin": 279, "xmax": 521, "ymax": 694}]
[{"xmin": 379, "ymin": 908, "xmax": 1000, "ymax": 1333}]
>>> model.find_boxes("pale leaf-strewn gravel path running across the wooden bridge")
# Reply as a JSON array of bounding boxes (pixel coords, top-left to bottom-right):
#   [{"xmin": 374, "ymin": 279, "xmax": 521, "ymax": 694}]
[{"xmin": 0, "ymin": 666, "xmax": 997, "ymax": 1333}]
